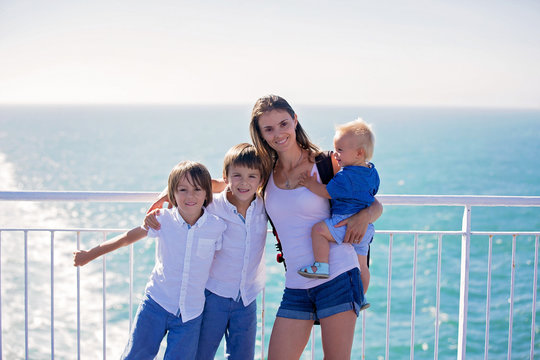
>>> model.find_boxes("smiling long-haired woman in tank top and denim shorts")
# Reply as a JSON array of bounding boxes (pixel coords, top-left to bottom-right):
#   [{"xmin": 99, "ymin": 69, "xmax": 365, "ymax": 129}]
[{"xmin": 250, "ymin": 95, "xmax": 382, "ymax": 360}]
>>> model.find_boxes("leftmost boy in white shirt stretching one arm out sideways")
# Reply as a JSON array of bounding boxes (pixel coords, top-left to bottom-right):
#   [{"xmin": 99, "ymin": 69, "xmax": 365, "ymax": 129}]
[{"xmin": 73, "ymin": 161, "xmax": 226, "ymax": 359}]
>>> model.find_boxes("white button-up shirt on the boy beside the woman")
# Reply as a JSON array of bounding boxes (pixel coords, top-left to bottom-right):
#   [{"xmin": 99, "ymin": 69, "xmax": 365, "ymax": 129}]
[{"xmin": 206, "ymin": 190, "xmax": 267, "ymax": 306}]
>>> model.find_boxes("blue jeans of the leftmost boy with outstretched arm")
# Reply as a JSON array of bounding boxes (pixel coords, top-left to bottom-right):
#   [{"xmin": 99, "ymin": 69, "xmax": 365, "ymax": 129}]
[{"xmin": 121, "ymin": 295, "xmax": 202, "ymax": 360}]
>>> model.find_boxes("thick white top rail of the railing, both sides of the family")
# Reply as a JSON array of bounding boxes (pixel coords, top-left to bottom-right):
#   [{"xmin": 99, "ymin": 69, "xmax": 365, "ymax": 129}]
[{"xmin": 0, "ymin": 191, "xmax": 540, "ymax": 207}]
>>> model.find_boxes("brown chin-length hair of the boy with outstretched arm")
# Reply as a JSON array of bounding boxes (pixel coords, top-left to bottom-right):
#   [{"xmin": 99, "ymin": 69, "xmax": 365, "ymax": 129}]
[{"xmin": 167, "ymin": 160, "xmax": 212, "ymax": 207}]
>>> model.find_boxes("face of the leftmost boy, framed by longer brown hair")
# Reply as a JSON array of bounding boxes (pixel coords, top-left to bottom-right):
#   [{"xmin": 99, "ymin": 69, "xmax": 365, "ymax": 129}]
[{"xmin": 174, "ymin": 174, "xmax": 206, "ymax": 220}]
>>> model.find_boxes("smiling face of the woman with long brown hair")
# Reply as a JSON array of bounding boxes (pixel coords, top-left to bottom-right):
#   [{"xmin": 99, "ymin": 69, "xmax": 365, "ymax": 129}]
[{"xmin": 259, "ymin": 110, "xmax": 298, "ymax": 153}]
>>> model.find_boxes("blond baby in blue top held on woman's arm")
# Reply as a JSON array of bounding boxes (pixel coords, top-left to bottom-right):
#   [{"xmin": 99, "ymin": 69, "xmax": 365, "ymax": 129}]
[{"xmin": 298, "ymin": 119, "xmax": 380, "ymax": 309}]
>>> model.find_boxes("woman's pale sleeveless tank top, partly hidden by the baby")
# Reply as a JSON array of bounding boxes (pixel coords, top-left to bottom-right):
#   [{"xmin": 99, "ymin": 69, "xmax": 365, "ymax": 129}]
[{"xmin": 265, "ymin": 165, "xmax": 358, "ymax": 289}]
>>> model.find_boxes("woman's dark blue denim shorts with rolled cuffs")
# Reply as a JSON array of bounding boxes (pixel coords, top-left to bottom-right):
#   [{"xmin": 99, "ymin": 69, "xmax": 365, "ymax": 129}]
[{"xmin": 276, "ymin": 268, "xmax": 364, "ymax": 322}]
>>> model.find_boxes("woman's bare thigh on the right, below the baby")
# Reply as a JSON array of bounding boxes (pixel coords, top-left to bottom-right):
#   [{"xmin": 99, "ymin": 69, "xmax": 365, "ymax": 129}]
[{"xmin": 321, "ymin": 310, "xmax": 356, "ymax": 360}]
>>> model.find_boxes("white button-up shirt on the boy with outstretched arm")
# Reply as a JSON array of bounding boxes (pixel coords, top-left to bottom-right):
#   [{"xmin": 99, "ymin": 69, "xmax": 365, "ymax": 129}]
[{"xmin": 146, "ymin": 208, "xmax": 227, "ymax": 322}]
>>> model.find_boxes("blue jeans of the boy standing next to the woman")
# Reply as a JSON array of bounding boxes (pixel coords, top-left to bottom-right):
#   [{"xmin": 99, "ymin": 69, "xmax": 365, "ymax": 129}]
[{"xmin": 197, "ymin": 290, "xmax": 257, "ymax": 360}]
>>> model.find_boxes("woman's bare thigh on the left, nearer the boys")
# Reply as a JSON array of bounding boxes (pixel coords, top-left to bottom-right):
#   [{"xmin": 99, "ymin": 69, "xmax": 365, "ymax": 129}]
[{"xmin": 268, "ymin": 317, "xmax": 313, "ymax": 360}]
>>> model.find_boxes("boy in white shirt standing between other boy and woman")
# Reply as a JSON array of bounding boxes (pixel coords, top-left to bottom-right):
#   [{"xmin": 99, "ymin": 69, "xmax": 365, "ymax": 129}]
[{"xmin": 145, "ymin": 143, "xmax": 267, "ymax": 360}]
